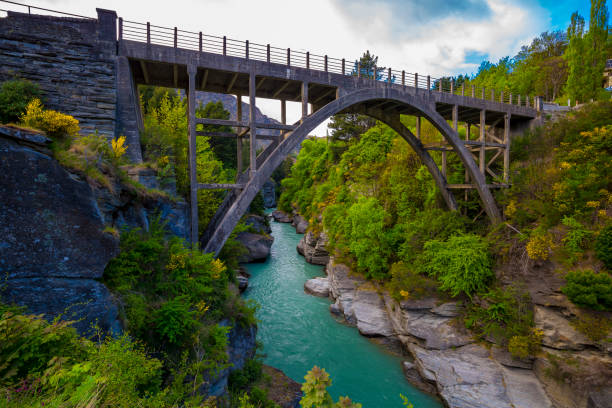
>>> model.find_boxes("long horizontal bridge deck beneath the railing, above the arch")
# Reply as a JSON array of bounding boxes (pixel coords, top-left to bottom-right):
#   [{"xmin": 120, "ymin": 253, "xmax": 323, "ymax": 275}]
[{"xmin": 119, "ymin": 40, "xmax": 537, "ymax": 125}]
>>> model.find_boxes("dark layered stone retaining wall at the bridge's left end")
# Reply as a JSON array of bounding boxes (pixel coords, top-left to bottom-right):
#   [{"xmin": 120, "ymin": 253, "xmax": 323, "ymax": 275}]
[{"xmin": 0, "ymin": 9, "xmax": 117, "ymax": 138}]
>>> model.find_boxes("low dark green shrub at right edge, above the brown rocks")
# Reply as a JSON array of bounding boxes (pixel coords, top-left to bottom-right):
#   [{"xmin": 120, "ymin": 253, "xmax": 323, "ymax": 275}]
[{"xmin": 562, "ymin": 269, "xmax": 612, "ymax": 311}]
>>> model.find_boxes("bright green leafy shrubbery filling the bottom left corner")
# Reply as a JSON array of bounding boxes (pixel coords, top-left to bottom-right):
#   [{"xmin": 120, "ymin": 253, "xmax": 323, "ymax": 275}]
[{"xmin": 0, "ymin": 306, "xmax": 165, "ymax": 408}]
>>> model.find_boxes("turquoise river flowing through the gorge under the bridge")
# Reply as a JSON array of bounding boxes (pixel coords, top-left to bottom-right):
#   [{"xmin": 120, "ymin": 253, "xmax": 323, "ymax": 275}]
[{"xmin": 245, "ymin": 221, "xmax": 442, "ymax": 408}]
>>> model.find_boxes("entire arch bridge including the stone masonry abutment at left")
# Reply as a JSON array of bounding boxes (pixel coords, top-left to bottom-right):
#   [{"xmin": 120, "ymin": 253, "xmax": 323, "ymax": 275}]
[{"xmin": 0, "ymin": 0, "xmax": 542, "ymax": 254}]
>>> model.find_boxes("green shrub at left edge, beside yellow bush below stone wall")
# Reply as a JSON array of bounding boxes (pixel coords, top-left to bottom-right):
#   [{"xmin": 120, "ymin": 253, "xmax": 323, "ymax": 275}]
[{"xmin": 0, "ymin": 79, "xmax": 40, "ymax": 123}]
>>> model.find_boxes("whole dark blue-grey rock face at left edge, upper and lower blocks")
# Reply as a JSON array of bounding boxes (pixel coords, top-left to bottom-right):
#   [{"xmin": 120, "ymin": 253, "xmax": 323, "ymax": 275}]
[{"xmin": 0, "ymin": 138, "xmax": 121, "ymax": 335}]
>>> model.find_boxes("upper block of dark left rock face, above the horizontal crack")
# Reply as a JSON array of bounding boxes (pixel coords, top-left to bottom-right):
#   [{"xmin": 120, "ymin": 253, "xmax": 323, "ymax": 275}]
[{"xmin": 0, "ymin": 138, "xmax": 118, "ymax": 279}]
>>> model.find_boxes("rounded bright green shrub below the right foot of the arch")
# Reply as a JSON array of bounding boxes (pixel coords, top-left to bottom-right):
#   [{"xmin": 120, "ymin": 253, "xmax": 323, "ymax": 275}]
[{"xmin": 421, "ymin": 234, "xmax": 494, "ymax": 297}]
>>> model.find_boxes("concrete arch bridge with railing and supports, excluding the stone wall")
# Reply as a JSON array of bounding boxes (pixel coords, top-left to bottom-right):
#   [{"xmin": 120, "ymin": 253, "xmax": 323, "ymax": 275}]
[{"xmin": 111, "ymin": 19, "xmax": 541, "ymax": 254}]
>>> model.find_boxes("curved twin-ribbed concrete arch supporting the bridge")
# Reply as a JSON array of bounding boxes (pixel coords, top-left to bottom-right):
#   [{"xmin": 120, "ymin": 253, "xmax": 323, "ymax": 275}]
[{"xmin": 203, "ymin": 87, "xmax": 501, "ymax": 255}]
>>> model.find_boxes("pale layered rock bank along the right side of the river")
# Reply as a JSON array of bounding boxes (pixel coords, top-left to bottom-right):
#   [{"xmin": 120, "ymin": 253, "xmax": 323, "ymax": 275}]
[{"xmin": 273, "ymin": 211, "xmax": 612, "ymax": 408}]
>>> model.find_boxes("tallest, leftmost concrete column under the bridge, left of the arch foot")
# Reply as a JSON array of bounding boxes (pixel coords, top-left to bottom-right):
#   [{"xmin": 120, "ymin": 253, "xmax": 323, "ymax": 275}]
[{"xmin": 187, "ymin": 64, "xmax": 198, "ymax": 245}]
